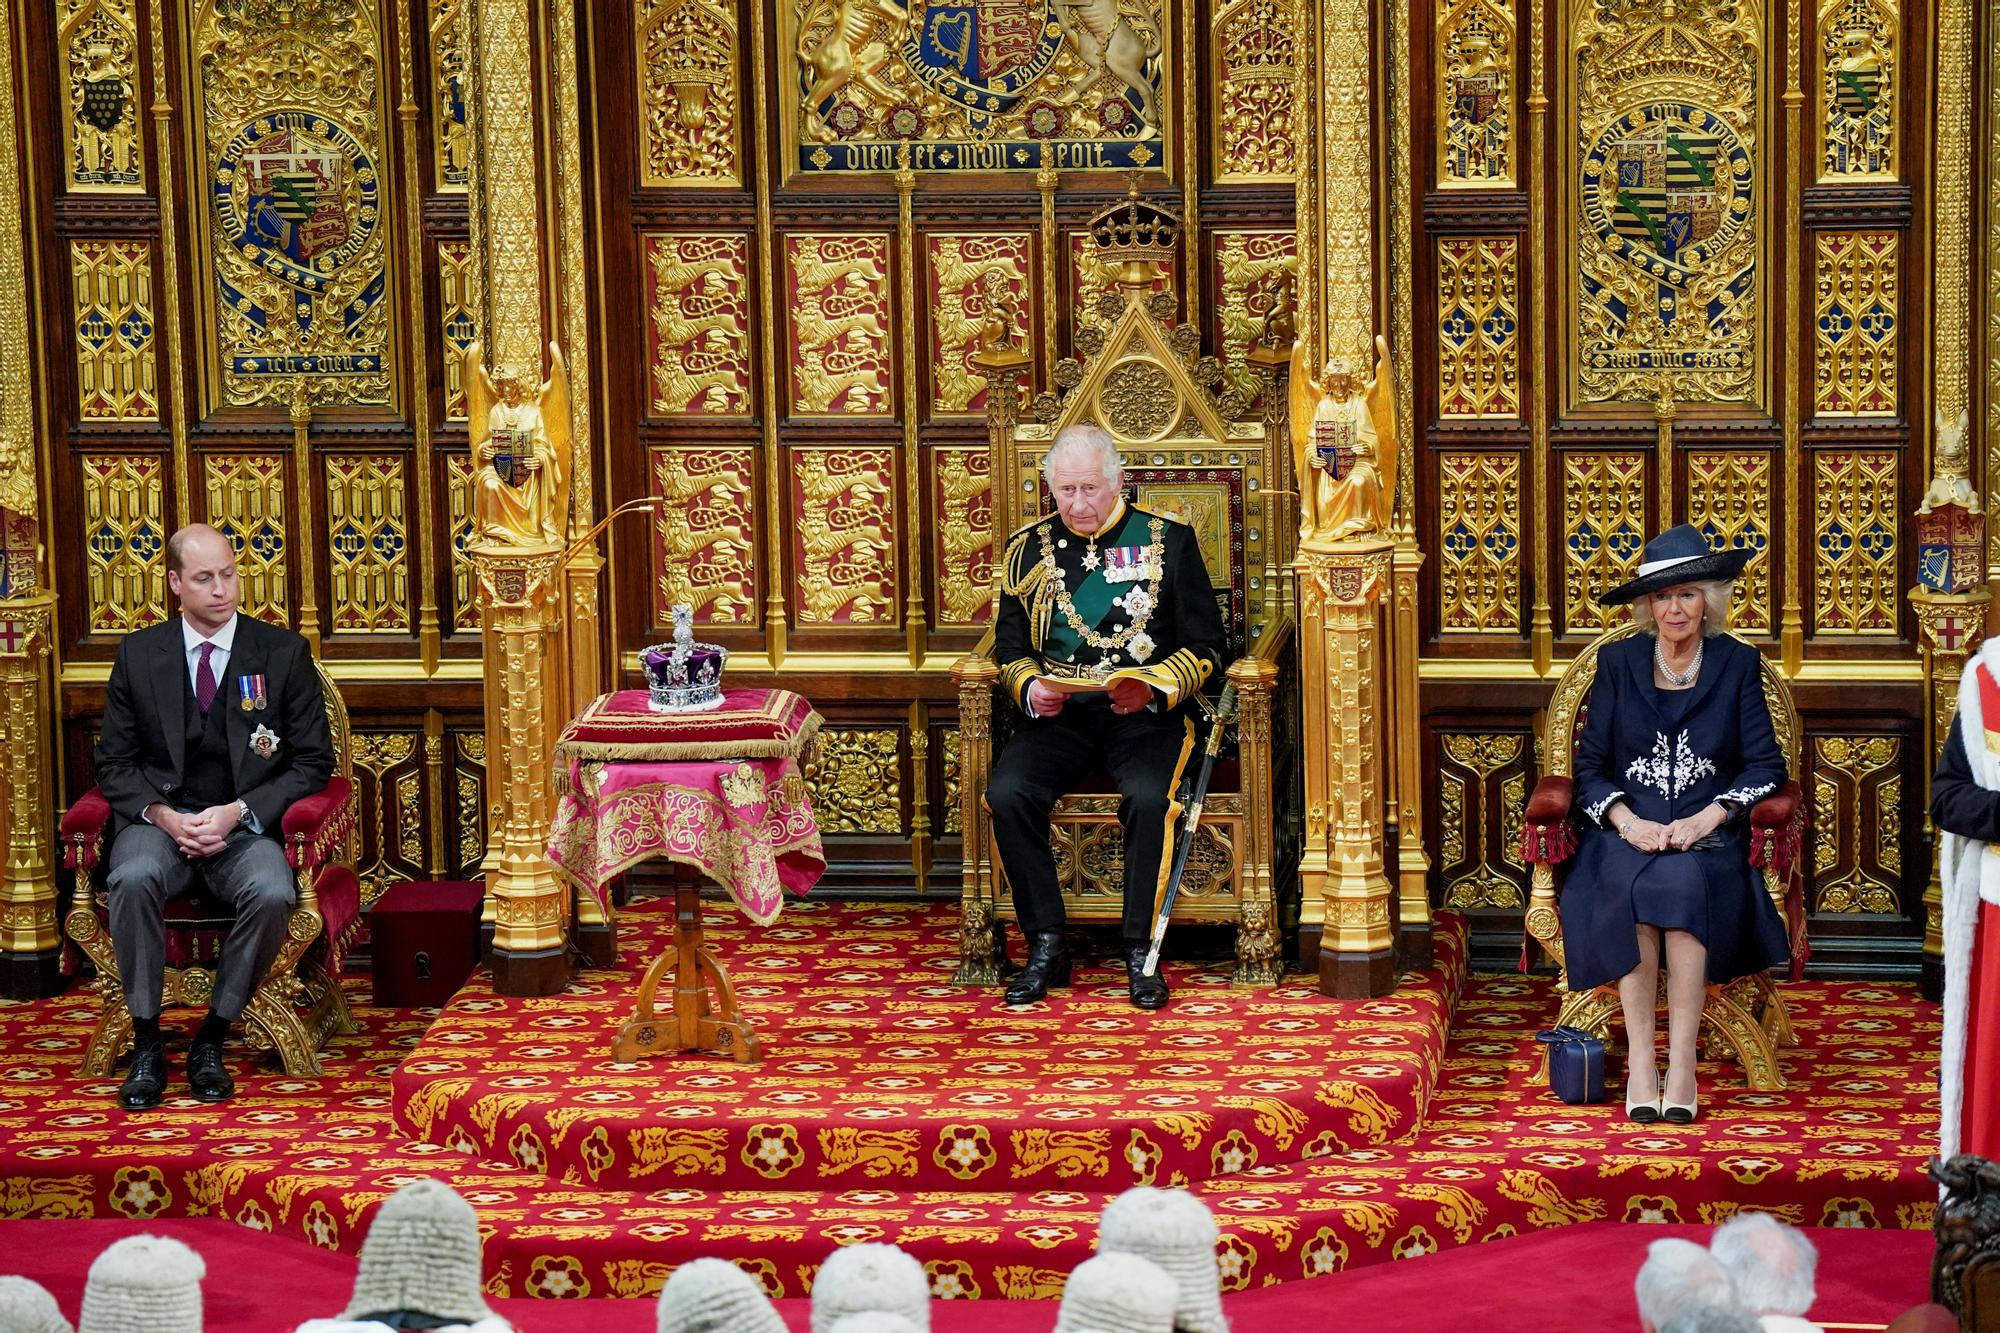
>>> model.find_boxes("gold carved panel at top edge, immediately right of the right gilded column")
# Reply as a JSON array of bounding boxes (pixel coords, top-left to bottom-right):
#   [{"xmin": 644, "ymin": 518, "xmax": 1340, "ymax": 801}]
[{"xmin": 1434, "ymin": 0, "xmax": 1516, "ymax": 190}]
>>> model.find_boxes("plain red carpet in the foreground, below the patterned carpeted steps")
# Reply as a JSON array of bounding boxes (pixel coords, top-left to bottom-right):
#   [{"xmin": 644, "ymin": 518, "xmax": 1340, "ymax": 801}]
[{"xmin": 0, "ymin": 1221, "xmax": 1930, "ymax": 1333}]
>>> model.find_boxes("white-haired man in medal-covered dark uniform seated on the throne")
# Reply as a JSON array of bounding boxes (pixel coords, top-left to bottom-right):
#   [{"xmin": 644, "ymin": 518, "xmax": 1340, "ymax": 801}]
[{"xmin": 986, "ymin": 424, "xmax": 1224, "ymax": 1009}]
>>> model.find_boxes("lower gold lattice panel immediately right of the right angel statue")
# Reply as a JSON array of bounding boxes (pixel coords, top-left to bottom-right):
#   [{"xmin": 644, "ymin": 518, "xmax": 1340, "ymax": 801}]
[{"xmin": 1438, "ymin": 452, "xmax": 1522, "ymax": 634}]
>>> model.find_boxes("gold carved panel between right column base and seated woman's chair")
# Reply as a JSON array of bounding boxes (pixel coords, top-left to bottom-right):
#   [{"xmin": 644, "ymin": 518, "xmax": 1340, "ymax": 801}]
[{"xmin": 1438, "ymin": 731, "xmax": 1532, "ymax": 911}]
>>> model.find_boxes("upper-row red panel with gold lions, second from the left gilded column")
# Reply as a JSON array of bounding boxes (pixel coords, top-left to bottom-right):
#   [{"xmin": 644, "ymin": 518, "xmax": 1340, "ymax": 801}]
[{"xmin": 784, "ymin": 232, "xmax": 894, "ymax": 416}]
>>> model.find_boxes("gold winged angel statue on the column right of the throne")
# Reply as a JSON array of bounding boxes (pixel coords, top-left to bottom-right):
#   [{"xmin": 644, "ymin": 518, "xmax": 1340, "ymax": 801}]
[{"xmin": 1290, "ymin": 336, "xmax": 1396, "ymax": 542}]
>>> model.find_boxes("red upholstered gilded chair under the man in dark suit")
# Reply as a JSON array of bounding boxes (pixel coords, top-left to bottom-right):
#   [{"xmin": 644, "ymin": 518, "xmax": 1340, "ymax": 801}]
[{"xmin": 62, "ymin": 662, "xmax": 362, "ymax": 1079}]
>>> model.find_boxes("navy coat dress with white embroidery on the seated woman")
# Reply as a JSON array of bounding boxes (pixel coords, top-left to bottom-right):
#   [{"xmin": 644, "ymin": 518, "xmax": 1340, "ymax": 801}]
[{"xmin": 1558, "ymin": 634, "xmax": 1790, "ymax": 991}]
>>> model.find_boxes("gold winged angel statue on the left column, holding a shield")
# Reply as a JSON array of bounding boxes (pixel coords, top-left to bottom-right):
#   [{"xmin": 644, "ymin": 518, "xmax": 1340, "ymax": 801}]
[{"xmin": 464, "ymin": 342, "xmax": 570, "ymax": 546}]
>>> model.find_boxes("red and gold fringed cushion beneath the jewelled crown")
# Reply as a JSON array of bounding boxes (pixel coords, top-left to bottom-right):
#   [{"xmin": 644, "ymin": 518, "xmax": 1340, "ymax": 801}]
[{"xmin": 556, "ymin": 689, "xmax": 820, "ymax": 767}]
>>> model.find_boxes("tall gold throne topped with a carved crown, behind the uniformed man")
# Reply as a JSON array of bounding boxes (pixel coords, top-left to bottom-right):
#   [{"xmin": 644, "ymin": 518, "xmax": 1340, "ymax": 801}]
[{"xmin": 952, "ymin": 188, "xmax": 1300, "ymax": 985}]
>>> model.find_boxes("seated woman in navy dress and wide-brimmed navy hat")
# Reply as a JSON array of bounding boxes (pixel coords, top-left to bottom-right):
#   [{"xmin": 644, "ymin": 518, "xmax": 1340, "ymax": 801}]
[{"xmin": 1560, "ymin": 524, "xmax": 1790, "ymax": 1125}]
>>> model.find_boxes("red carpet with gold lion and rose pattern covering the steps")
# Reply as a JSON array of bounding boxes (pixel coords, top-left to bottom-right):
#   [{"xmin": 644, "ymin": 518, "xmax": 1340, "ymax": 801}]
[{"xmin": 0, "ymin": 903, "xmax": 1938, "ymax": 1301}]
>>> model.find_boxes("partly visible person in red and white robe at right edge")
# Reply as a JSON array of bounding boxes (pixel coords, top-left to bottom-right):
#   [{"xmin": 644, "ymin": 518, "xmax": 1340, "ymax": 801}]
[{"xmin": 1930, "ymin": 640, "xmax": 2000, "ymax": 1159}]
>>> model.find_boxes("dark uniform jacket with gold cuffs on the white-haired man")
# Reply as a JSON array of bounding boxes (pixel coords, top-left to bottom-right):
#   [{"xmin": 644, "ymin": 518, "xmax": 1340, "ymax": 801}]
[{"xmin": 994, "ymin": 504, "xmax": 1226, "ymax": 709}]
